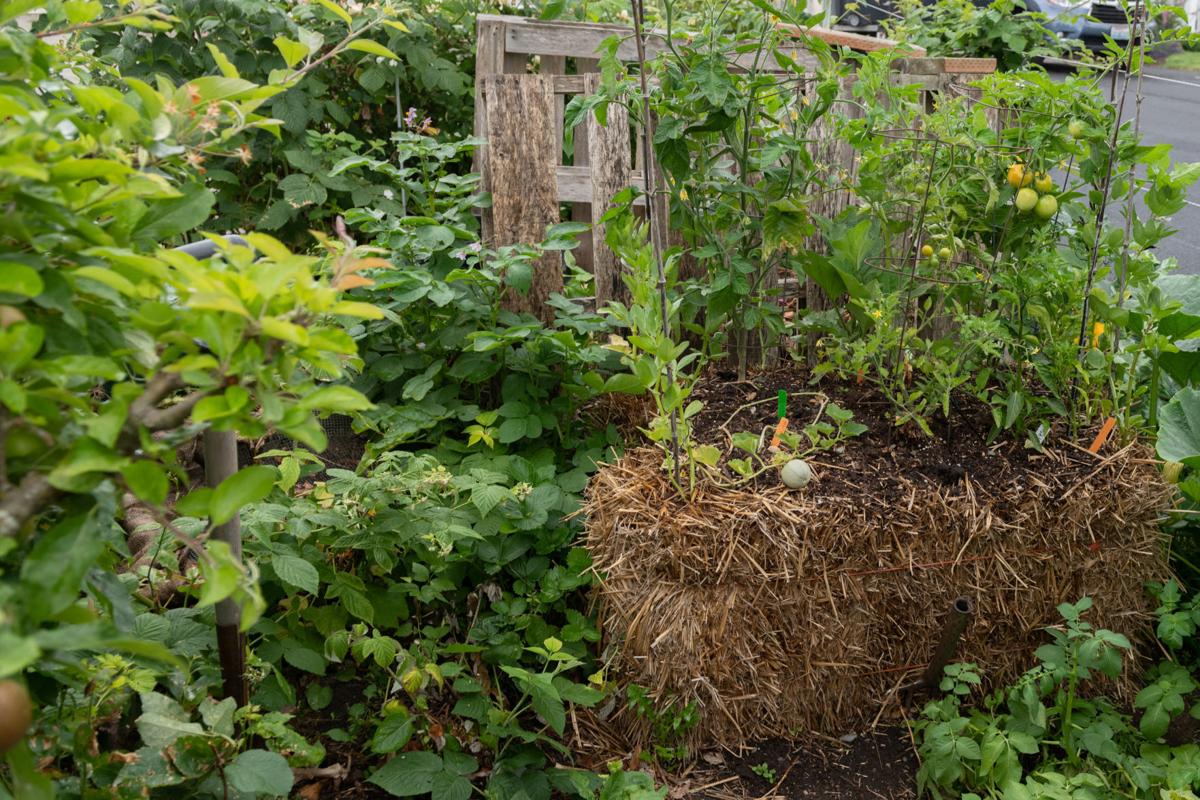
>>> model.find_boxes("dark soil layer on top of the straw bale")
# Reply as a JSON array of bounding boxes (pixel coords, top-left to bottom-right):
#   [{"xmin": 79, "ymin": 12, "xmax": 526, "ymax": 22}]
[{"xmin": 692, "ymin": 367, "xmax": 1094, "ymax": 498}]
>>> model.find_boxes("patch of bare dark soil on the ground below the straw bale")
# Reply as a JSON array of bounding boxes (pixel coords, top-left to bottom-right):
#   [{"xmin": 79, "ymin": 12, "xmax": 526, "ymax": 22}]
[{"xmin": 686, "ymin": 727, "xmax": 917, "ymax": 800}]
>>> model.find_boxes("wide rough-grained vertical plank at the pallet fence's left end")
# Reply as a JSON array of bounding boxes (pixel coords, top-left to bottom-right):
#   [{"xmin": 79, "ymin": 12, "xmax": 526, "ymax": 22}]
[{"xmin": 484, "ymin": 74, "xmax": 563, "ymax": 323}]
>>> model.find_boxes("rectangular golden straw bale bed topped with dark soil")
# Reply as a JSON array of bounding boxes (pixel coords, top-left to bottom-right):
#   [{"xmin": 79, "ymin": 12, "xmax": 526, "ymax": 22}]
[{"xmin": 587, "ymin": 371, "xmax": 1170, "ymax": 745}]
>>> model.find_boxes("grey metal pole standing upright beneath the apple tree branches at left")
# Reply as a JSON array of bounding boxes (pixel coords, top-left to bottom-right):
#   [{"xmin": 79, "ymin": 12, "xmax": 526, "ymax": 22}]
[{"xmin": 204, "ymin": 428, "xmax": 250, "ymax": 706}]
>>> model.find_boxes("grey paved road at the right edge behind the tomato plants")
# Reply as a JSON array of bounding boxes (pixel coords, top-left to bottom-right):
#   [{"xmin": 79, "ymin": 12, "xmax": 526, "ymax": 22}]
[{"xmin": 1060, "ymin": 61, "xmax": 1200, "ymax": 273}]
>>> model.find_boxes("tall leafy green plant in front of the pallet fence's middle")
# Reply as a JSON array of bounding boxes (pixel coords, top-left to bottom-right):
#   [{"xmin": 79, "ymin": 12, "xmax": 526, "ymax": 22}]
[{"xmin": 575, "ymin": 2, "xmax": 839, "ymax": 378}]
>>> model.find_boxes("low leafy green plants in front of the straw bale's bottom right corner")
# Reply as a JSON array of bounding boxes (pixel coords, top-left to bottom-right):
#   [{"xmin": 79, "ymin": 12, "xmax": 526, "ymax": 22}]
[{"xmin": 916, "ymin": 599, "xmax": 1200, "ymax": 800}]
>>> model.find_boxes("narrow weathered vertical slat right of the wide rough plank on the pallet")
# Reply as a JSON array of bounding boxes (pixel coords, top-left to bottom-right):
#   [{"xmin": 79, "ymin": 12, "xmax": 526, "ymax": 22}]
[{"xmin": 586, "ymin": 73, "xmax": 632, "ymax": 307}]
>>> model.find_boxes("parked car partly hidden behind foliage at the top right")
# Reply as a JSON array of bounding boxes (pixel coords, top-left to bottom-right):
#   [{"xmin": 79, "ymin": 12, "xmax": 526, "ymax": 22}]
[{"xmin": 829, "ymin": 0, "xmax": 1129, "ymax": 50}]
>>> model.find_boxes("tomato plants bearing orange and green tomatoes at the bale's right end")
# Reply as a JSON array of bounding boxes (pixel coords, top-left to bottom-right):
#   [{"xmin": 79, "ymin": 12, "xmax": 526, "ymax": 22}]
[{"xmin": 800, "ymin": 51, "xmax": 1196, "ymax": 449}]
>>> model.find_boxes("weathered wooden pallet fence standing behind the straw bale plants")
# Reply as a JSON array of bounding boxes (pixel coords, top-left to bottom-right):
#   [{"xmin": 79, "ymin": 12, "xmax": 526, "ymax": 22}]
[{"xmin": 475, "ymin": 14, "xmax": 995, "ymax": 320}]
